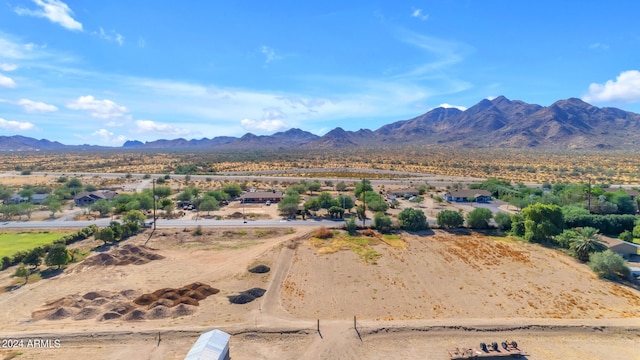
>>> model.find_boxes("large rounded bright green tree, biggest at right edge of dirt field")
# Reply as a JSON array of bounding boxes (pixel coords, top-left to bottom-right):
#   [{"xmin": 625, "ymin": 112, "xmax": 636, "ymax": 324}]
[{"xmin": 522, "ymin": 203, "xmax": 564, "ymax": 242}]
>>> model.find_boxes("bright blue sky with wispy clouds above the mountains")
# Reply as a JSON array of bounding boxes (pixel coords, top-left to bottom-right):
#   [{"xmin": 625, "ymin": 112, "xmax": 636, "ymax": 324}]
[{"xmin": 0, "ymin": 0, "xmax": 640, "ymax": 146}]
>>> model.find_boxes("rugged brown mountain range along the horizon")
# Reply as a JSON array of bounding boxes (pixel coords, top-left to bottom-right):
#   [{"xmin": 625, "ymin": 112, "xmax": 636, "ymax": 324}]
[{"xmin": 0, "ymin": 96, "xmax": 640, "ymax": 151}]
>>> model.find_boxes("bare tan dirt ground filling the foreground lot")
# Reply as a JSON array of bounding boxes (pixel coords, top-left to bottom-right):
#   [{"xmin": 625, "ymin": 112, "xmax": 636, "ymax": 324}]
[{"xmin": 0, "ymin": 228, "xmax": 640, "ymax": 360}]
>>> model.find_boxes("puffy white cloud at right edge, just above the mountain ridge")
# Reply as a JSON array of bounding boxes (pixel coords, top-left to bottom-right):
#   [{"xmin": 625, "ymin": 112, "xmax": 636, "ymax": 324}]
[{"xmin": 582, "ymin": 70, "xmax": 640, "ymax": 102}]
